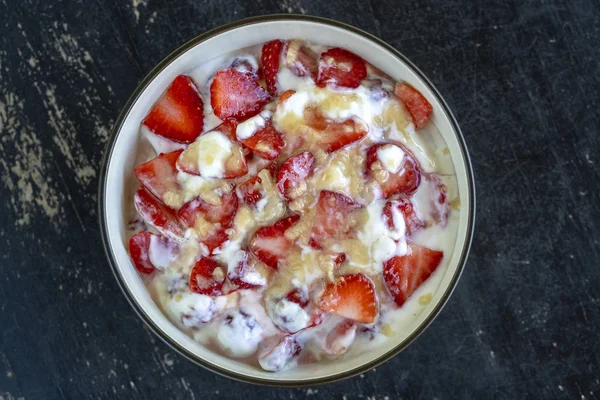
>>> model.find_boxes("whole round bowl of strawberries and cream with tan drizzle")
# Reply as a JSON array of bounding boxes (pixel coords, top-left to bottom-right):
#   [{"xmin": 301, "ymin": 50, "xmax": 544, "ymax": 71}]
[{"xmin": 100, "ymin": 17, "xmax": 474, "ymax": 385}]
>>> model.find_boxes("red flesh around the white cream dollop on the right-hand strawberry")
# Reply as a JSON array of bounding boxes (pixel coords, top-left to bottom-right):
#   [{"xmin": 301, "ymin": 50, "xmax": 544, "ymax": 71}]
[{"xmin": 366, "ymin": 143, "xmax": 421, "ymax": 198}]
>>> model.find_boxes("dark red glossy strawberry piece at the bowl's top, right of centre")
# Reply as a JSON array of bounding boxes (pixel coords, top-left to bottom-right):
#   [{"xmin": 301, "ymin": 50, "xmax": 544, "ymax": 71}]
[{"xmin": 317, "ymin": 47, "xmax": 367, "ymax": 88}]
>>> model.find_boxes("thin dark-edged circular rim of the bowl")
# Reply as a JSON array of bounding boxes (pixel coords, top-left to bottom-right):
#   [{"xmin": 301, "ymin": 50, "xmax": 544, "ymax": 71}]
[{"xmin": 98, "ymin": 14, "xmax": 476, "ymax": 388}]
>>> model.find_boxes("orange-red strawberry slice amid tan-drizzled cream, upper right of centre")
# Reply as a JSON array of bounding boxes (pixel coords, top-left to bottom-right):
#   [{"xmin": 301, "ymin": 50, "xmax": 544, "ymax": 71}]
[{"xmin": 304, "ymin": 108, "xmax": 369, "ymax": 153}]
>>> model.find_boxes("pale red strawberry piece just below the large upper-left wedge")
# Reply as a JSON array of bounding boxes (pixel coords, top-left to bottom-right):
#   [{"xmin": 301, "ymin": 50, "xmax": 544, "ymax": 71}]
[{"xmin": 133, "ymin": 150, "xmax": 182, "ymax": 201}]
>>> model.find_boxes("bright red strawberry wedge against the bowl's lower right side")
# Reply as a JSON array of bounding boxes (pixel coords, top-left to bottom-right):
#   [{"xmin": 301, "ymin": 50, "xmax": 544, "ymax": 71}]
[{"xmin": 383, "ymin": 243, "xmax": 444, "ymax": 306}]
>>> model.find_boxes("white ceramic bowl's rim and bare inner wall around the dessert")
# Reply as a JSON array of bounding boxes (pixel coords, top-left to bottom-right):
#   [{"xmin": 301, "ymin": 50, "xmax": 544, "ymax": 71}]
[{"xmin": 98, "ymin": 15, "xmax": 475, "ymax": 386}]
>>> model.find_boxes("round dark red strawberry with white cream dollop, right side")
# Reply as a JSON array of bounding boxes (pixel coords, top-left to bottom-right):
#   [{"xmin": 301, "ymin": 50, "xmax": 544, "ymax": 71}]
[{"xmin": 366, "ymin": 143, "xmax": 421, "ymax": 198}]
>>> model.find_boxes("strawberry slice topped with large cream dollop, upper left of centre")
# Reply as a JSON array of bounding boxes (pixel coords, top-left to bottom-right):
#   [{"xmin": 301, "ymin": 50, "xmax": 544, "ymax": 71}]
[{"xmin": 177, "ymin": 128, "xmax": 248, "ymax": 179}]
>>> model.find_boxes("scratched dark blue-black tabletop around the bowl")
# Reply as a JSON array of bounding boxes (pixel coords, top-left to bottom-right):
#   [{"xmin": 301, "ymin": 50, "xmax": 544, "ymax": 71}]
[{"xmin": 0, "ymin": 0, "xmax": 600, "ymax": 400}]
